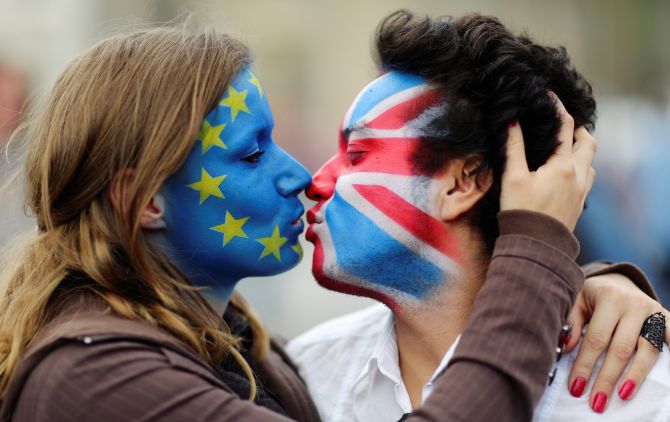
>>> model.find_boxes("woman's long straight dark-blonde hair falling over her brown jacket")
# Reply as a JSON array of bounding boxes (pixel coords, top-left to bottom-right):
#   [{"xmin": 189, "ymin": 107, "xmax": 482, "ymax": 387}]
[{"xmin": 0, "ymin": 28, "xmax": 269, "ymax": 397}]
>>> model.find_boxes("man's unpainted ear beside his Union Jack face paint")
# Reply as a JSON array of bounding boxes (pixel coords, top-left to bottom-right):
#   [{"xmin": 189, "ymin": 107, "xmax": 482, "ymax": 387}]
[{"xmin": 438, "ymin": 158, "xmax": 493, "ymax": 222}]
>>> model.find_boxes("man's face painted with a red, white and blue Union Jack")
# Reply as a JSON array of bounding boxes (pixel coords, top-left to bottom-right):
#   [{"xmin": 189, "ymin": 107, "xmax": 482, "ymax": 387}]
[{"xmin": 307, "ymin": 72, "xmax": 460, "ymax": 308}]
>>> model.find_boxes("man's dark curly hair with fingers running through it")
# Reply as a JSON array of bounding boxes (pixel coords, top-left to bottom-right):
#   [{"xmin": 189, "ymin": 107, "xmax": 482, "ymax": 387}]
[{"xmin": 375, "ymin": 10, "xmax": 596, "ymax": 252}]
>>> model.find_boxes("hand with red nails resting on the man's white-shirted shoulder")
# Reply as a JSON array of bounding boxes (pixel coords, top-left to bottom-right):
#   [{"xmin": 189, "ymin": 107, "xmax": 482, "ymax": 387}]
[{"xmin": 565, "ymin": 273, "xmax": 670, "ymax": 409}]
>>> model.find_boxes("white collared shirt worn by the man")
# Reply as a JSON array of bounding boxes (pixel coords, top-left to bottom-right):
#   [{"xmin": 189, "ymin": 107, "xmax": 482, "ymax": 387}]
[{"xmin": 287, "ymin": 304, "xmax": 670, "ymax": 422}]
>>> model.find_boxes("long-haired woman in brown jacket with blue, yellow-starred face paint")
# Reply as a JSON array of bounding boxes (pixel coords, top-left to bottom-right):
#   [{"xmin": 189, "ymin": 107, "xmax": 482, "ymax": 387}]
[{"xmin": 0, "ymin": 29, "xmax": 664, "ymax": 421}]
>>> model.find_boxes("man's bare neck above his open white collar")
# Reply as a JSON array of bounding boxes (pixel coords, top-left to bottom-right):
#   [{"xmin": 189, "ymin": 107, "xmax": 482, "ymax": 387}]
[{"xmin": 394, "ymin": 264, "xmax": 484, "ymax": 408}]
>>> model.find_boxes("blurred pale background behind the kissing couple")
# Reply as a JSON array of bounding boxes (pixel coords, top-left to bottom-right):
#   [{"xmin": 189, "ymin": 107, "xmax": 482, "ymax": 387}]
[{"xmin": 0, "ymin": 0, "xmax": 670, "ymax": 337}]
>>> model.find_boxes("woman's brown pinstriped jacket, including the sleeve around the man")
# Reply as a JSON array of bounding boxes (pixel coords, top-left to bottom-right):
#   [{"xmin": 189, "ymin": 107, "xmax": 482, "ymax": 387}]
[{"xmin": 0, "ymin": 211, "xmax": 653, "ymax": 422}]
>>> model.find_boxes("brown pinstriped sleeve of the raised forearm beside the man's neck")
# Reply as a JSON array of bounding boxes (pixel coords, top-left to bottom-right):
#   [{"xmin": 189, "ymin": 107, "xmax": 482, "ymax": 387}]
[{"xmin": 409, "ymin": 211, "xmax": 584, "ymax": 421}]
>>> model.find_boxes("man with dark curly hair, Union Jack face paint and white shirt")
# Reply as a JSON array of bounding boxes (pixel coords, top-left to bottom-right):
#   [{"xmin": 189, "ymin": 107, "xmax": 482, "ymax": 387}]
[{"xmin": 288, "ymin": 11, "xmax": 670, "ymax": 421}]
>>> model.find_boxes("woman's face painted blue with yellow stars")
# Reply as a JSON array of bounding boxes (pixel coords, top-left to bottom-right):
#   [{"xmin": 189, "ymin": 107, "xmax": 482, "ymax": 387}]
[{"xmin": 160, "ymin": 69, "xmax": 311, "ymax": 299}]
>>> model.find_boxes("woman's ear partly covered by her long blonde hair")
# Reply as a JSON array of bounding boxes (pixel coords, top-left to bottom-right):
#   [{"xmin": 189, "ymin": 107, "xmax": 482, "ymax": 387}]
[{"xmin": 109, "ymin": 169, "xmax": 165, "ymax": 229}]
